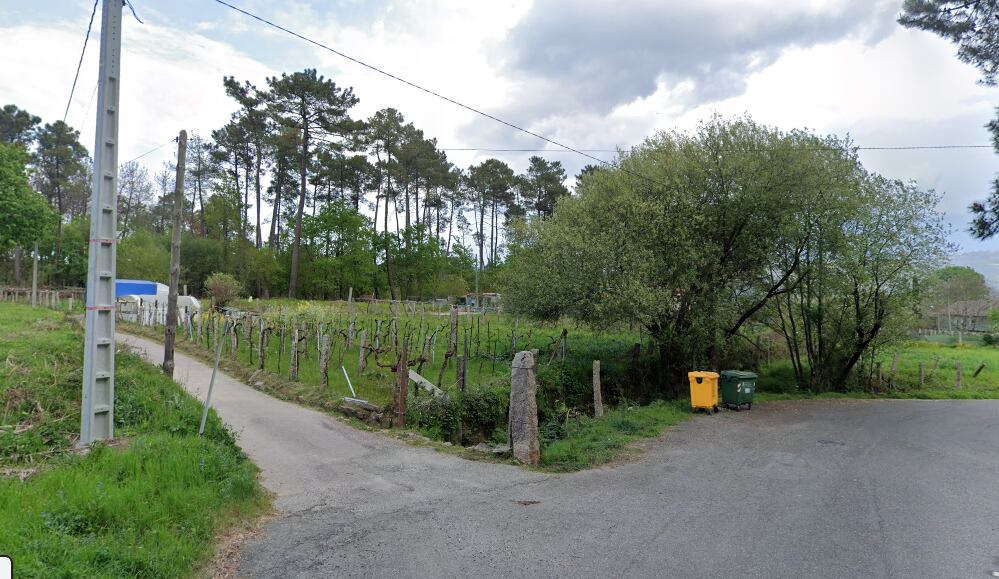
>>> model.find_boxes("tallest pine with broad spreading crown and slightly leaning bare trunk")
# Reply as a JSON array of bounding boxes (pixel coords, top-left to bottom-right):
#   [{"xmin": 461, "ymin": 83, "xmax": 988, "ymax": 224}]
[{"xmin": 260, "ymin": 68, "xmax": 358, "ymax": 298}]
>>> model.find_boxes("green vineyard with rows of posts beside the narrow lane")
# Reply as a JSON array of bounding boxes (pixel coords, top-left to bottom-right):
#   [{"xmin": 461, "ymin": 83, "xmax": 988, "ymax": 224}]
[{"xmin": 119, "ymin": 300, "xmax": 654, "ymax": 444}]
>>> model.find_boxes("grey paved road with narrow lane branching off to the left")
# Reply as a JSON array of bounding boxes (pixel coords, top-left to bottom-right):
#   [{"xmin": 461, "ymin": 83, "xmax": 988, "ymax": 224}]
[{"xmin": 127, "ymin": 337, "xmax": 999, "ymax": 578}]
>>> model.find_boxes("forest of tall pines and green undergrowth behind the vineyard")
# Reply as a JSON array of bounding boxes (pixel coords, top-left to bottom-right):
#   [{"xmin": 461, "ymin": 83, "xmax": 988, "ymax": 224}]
[{"xmin": 0, "ymin": 69, "xmax": 569, "ymax": 299}]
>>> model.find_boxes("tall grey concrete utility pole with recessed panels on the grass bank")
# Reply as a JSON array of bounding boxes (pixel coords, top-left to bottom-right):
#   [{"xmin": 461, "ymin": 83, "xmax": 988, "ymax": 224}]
[{"xmin": 79, "ymin": 0, "xmax": 122, "ymax": 446}]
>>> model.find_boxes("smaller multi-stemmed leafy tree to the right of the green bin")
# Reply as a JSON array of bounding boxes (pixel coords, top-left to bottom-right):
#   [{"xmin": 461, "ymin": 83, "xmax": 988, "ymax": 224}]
[{"xmin": 767, "ymin": 171, "xmax": 948, "ymax": 391}]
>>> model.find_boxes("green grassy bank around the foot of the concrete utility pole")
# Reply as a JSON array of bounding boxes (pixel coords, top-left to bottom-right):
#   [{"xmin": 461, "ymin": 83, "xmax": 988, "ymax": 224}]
[{"xmin": 0, "ymin": 304, "xmax": 268, "ymax": 577}]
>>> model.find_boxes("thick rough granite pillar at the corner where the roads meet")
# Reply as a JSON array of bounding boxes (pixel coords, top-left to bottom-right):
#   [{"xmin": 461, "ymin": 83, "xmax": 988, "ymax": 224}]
[{"xmin": 509, "ymin": 352, "xmax": 541, "ymax": 466}]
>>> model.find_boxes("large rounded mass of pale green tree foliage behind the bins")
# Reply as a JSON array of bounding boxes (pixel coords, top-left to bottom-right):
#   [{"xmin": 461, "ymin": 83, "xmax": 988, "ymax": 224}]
[{"xmin": 504, "ymin": 113, "xmax": 942, "ymax": 393}]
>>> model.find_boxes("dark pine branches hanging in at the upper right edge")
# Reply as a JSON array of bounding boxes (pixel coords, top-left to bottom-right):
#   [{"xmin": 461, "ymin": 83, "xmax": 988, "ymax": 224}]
[{"xmin": 898, "ymin": 0, "xmax": 999, "ymax": 239}]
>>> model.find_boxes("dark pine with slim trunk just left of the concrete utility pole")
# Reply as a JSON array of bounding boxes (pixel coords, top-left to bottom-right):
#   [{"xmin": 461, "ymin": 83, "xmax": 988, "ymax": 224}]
[{"xmin": 34, "ymin": 121, "xmax": 89, "ymax": 286}]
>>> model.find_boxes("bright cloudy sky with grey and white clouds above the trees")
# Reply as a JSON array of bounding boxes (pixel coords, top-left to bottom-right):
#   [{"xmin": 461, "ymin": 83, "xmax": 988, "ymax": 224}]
[{"xmin": 0, "ymin": 0, "xmax": 999, "ymax": 252}]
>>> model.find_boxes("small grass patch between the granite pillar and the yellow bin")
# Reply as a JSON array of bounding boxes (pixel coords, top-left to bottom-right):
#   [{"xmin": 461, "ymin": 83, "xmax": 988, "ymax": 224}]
[{"xmin": 541, "ymin": 401, "xmax": 691, "ymax": 472}]
